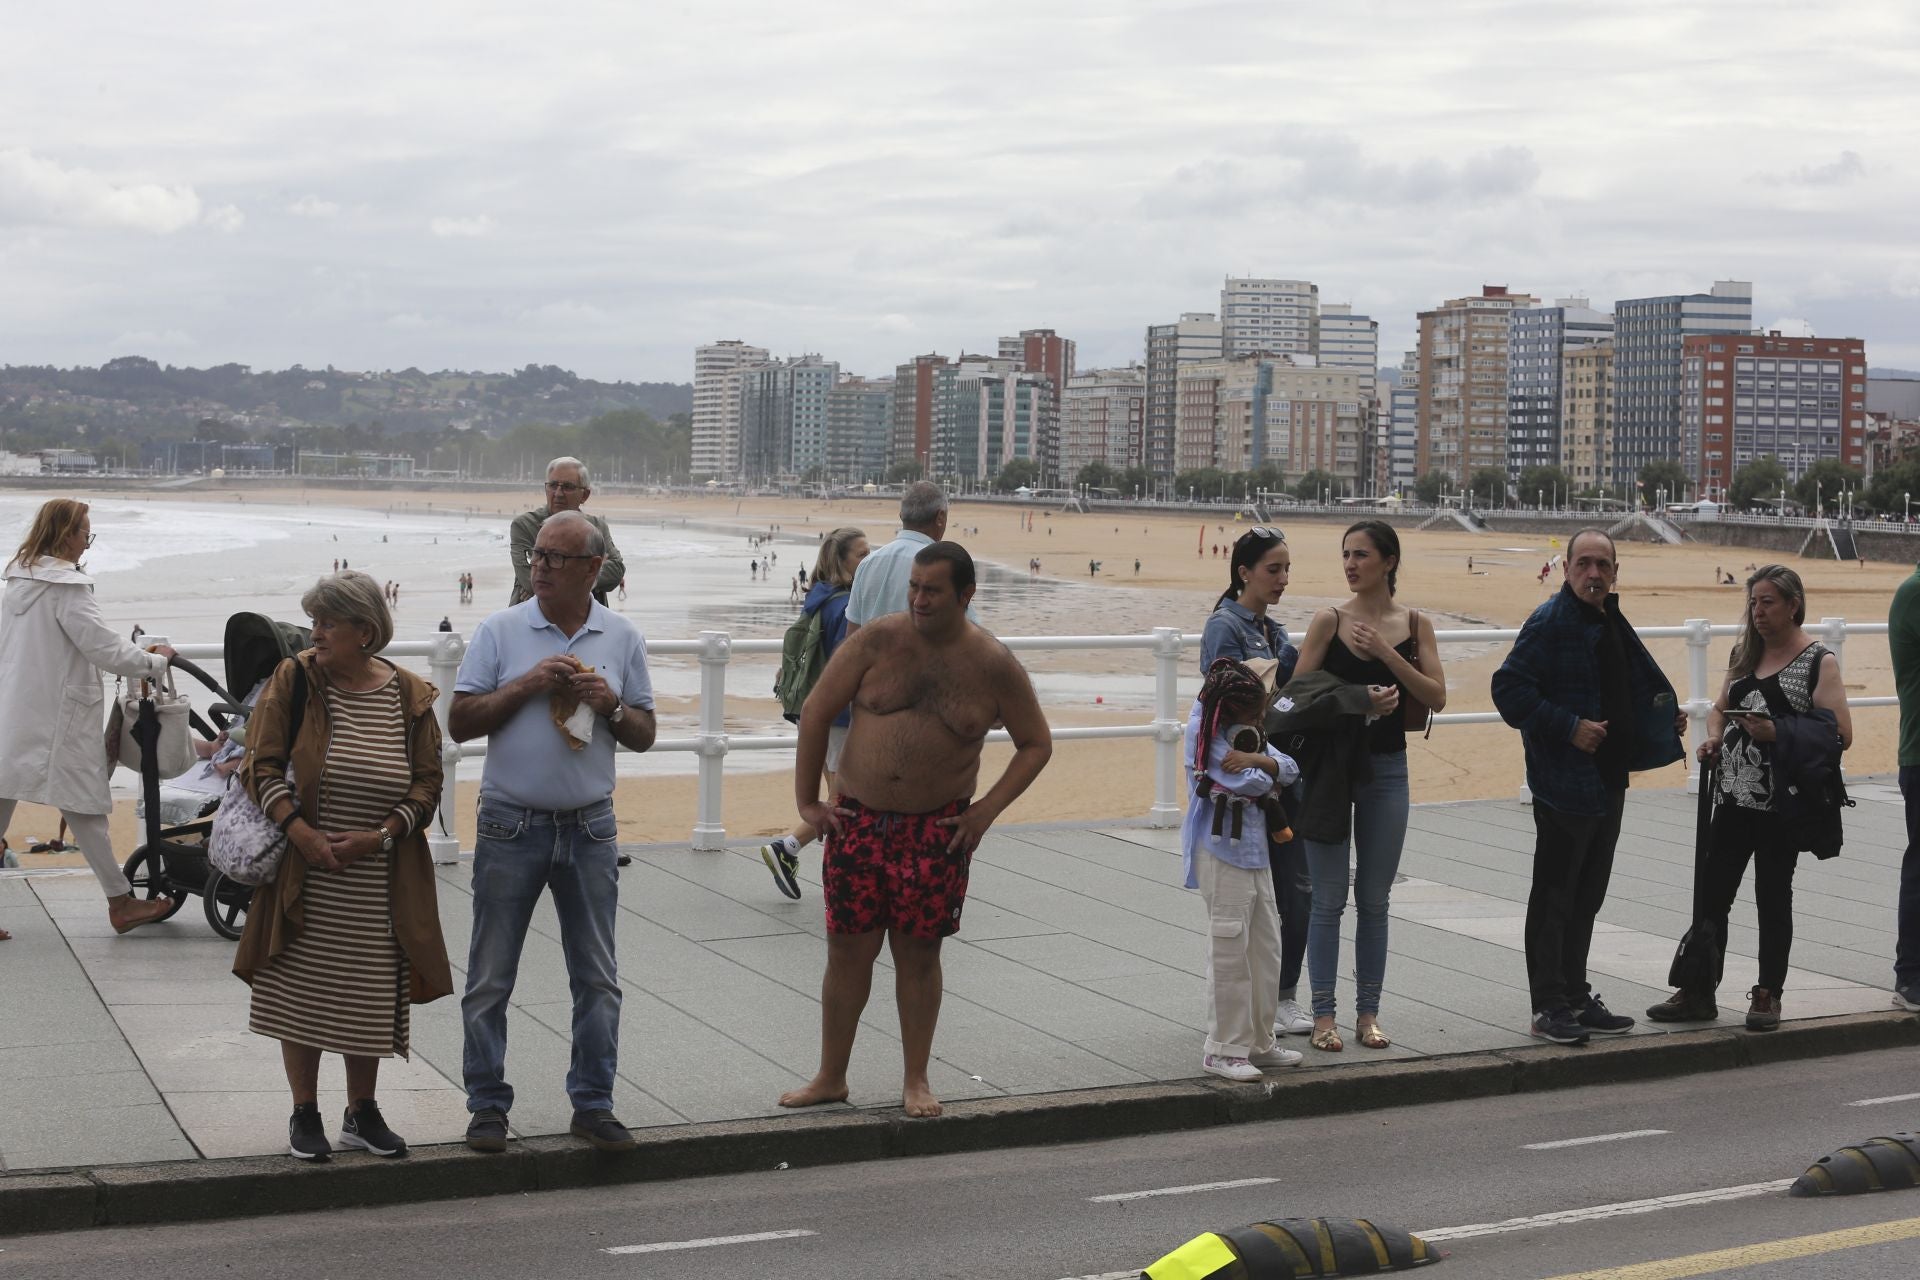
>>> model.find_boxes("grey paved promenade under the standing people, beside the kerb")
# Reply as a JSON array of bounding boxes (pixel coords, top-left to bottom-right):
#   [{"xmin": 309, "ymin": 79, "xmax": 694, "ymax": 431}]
[{"xmin": 0, "ymin": 777, "xmax": 1905, "ymax": 1192}]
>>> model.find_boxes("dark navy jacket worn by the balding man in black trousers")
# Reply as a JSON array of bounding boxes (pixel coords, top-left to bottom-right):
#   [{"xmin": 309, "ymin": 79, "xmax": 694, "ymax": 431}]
[{"xmin": 1494, "ymin": 583, "xmax": 1686, "ymax": 818}]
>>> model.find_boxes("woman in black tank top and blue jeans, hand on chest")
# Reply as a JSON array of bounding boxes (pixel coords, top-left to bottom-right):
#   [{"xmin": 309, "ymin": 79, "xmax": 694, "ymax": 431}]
[{"xmin": 1298, "ymin": 520, "xmax": 1446, "ymax": 1052}]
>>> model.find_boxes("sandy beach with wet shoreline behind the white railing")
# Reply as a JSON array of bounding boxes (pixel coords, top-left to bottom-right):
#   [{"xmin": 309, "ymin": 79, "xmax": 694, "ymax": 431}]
[{"xmin": 0, "ymin": 487, "xmax": 1910, "ymax": 865}]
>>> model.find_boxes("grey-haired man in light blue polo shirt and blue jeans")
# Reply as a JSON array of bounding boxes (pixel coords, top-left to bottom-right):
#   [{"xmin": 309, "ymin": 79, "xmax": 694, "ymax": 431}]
[{"xmin": 447, "ymin": 512, "xmax": 655, "ymax": 1151}]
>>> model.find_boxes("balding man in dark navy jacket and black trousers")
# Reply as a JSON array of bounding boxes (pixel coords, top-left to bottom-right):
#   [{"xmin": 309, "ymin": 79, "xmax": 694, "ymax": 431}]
[{"xmin": 1494, "ymin": 530, "xmax": 1686, "ymax": 1044}]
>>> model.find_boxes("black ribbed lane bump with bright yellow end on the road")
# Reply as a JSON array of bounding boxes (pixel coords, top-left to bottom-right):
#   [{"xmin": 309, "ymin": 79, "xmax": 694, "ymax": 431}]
[{"xmin": 1140, "ymin": 1219, "xmax": 1440, "ymax": 1280}]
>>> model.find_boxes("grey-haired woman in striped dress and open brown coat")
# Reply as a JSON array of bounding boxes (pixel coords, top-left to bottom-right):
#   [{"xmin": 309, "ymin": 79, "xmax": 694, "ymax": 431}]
[{"xmin": 234, "ymin": 570, "xmax": 453, "ymax": 1159}]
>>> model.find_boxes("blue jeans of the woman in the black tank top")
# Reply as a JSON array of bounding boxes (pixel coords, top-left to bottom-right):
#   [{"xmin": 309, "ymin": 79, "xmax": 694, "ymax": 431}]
[{"xmin": 1302, "ymin": 750, "xmax": 1407, "ymax": 1017}]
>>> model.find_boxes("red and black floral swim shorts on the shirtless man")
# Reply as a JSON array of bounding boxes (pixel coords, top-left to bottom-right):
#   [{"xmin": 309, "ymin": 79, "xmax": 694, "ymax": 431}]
[{"xmin": 820, "ymin": 796, "xmax": 973, "ymax": 940}]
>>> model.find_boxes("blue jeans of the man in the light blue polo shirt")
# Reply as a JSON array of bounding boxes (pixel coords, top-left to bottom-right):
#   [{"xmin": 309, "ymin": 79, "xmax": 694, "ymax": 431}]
[{"xmin": 461, "ymin": 800, "xmax": 620, "ymax": 1111}]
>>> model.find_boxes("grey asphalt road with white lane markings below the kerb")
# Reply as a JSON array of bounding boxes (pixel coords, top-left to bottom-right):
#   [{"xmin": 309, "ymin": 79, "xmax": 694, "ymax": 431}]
[{"xmin": 0, "ymin": 1050, "xmax": 1920, "ymax": 1280}]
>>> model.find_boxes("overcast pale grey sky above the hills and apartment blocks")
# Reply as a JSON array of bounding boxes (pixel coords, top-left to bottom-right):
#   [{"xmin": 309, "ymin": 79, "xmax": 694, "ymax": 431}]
[{"xmin": 0, "ymin": 0, "xmax": 1920, "ymax": 382}]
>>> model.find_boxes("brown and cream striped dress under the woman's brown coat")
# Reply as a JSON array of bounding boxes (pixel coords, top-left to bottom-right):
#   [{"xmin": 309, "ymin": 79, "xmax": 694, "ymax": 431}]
[{"xmin": 248, "ymin": 672, "xmax": 420, "ymax": 1057}]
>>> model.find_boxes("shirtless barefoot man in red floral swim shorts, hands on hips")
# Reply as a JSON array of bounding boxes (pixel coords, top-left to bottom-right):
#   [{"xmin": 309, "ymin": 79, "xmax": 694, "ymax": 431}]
[{"xmin": 780, "ymin": 541, "xmax": 1054, "ymax": 1117}]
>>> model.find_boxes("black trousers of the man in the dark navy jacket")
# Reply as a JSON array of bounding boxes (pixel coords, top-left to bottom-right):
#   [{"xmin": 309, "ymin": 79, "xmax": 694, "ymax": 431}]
[{"xmin": 1526, "ymin": 787, "xmax": 1626, "ymax": 1013}]
